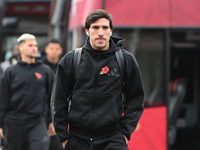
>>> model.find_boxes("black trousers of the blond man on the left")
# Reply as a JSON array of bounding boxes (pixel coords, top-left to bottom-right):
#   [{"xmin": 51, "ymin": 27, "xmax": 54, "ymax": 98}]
[{"xmin": 4, "ymin": 121, "xmax": 49, "ymax": 150}]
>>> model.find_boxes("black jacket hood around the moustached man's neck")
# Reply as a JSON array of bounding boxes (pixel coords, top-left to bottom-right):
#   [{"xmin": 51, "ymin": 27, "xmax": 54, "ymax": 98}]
[{"xmin": 83, "ymin": 36, "xmax": 125, "ymax": 55}]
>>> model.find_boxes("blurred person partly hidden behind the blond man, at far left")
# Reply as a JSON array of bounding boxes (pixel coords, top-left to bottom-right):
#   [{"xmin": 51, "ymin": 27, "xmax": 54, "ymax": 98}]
[{"xmin": 1, "ymin": 43, "xmax": 20, "ymax": 72}]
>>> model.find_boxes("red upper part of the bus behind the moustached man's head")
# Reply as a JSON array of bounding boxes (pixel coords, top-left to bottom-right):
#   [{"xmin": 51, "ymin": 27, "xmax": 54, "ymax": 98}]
[{"xmin": 69, "ymin": 0, "xmax": 200, "ymax": 29}]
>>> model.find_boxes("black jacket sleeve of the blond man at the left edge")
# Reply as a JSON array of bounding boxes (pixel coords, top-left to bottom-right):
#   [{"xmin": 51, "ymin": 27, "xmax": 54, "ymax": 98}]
[{"xmin": 0, "ymin": 70, "xmax": 11, "ymax": 128}]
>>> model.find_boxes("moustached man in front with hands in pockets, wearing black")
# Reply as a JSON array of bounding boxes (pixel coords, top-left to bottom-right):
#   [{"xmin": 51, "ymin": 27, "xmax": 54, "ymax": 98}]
[{"xmin": 52, "ymin": 10, "xmax": 144, "ymax": 150}]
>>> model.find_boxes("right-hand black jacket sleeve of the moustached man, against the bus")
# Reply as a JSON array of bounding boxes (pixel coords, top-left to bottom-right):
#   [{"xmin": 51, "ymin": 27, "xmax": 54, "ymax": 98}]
[{"xmin": 120, "ymin": 52, "xmax": 144, "ymax": 140}]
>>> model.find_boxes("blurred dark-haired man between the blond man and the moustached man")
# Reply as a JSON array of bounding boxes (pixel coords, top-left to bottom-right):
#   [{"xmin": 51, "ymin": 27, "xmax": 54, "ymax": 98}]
[{"xmin": 43, "ymin": 39, "xmax": 63, "ymax": 150}]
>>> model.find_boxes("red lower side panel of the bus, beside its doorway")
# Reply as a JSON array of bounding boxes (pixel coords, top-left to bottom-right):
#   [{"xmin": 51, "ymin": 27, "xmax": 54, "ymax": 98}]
[{"xmin": 128, "ymin": 106, "xmax": 167, "ymax": 150}]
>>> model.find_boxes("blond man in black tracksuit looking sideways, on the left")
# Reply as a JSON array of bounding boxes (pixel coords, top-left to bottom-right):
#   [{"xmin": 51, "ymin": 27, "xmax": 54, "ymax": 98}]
[{"xmin": 0, "ymin": 34, "xmax": 54, "ymax": 150}]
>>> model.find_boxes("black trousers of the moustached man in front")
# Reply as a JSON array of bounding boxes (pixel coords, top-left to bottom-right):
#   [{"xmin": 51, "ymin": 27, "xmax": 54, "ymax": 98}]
[{"xmin": 65, "ymin": 132, "xmax": 127, "ymax": 150}]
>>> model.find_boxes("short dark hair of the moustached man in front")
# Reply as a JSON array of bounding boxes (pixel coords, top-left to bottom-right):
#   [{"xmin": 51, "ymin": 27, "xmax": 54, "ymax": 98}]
[{"xmin": 85, "ymin": 9, "xmax": 113, "ymax": 29}]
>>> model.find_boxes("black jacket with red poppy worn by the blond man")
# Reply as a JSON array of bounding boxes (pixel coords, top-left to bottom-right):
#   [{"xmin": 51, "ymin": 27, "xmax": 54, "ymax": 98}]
[{"xmin": 0, "ymin": 59, "xmax": 54, "ymax": 128}]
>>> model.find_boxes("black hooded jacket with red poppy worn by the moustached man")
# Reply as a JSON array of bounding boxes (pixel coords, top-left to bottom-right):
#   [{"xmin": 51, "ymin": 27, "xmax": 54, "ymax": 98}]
[{"xmin": 52, "ymin": 37, "xmax": 144, "ymax": 142}]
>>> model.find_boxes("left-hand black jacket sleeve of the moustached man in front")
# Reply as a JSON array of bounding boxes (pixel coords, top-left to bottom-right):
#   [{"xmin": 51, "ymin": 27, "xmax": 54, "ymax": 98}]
[{"xmin": 51, "ymin": 52, "xmax": 72, "ymax": 142}]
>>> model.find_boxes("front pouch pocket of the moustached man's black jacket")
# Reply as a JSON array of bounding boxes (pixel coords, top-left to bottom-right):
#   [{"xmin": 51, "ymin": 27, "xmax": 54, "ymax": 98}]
[{"xmin": 68, "ymin": 93, "xmax": 119, "ymax": 134}]
